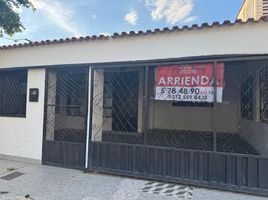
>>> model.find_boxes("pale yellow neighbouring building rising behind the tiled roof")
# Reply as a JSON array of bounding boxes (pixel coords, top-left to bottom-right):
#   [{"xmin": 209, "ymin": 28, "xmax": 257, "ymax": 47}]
[{"xmin": 237, "ymin": 0, "xmax": 268, "ymax": 21}]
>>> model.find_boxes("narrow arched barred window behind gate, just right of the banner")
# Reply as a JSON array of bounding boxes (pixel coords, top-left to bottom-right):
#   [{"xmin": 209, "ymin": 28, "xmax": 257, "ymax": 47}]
[{"xmin": 241, "ymin": 76, "xmax": 254, "ymax": 120}]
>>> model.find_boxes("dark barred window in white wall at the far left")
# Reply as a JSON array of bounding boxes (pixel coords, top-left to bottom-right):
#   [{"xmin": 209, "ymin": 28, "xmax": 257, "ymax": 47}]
[{"xmin": 0, "ymin": 70, "xmax": 27, "ymax": 117}]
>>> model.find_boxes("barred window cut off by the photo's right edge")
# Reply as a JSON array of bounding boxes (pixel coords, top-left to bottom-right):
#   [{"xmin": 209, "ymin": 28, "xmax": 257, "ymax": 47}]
[{"xmin": 260, "ymin": 67, "xmax": 268, "ymax": 122}]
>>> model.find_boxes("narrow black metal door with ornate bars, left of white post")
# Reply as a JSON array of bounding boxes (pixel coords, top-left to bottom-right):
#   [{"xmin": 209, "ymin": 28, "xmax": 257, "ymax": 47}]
[{"xmin": 43, "ymin": 68, "xmax": 88, "ymax": 168}]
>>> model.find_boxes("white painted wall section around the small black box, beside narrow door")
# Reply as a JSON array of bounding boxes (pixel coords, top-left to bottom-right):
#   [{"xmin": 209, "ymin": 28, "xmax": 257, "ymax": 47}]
[{"xmin": 0, "ymin": 69, "xmax": 45, "ymax": 161}]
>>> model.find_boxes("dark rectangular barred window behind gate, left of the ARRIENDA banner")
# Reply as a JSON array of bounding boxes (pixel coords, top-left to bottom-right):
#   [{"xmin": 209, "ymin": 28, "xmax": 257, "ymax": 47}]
[{"xmin": 104, "ymin": 71, "xmax": 139, "ymax": 132}]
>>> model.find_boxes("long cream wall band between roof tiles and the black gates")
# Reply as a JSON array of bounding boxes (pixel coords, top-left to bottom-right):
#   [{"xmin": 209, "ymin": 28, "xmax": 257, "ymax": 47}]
[{"xmin": 0, "ymin": 22, "xmax": 268, "ymax": 68}]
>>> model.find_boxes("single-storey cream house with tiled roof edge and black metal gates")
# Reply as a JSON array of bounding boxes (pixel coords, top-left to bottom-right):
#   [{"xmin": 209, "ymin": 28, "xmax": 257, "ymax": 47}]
[{"xmin": 0, "ymin": 17, "xmax": 268, "ymax": 196}]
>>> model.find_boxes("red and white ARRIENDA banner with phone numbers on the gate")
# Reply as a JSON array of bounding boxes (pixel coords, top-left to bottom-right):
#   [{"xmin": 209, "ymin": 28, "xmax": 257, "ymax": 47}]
[{"xmin": 155, "ymin": 63, "xmax": 224, "ymax": 102}]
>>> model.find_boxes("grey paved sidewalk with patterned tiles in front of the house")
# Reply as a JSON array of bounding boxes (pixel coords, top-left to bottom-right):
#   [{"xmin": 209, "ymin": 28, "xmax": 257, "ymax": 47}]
[{"xmin": 0, "ymin": 160, "xmax": 267, "ymax": 200}]
